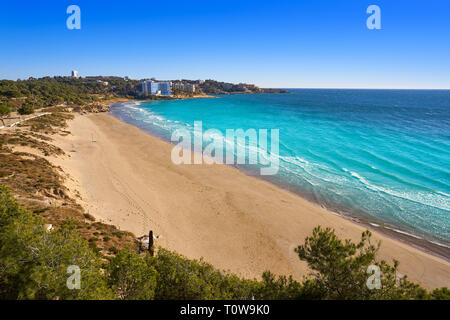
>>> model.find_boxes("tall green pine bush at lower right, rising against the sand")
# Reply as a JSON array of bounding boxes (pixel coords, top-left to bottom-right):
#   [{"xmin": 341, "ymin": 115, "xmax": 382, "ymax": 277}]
[{"xmin": 295, "ymin": 226, "xmax": 427, "ymax": 299}]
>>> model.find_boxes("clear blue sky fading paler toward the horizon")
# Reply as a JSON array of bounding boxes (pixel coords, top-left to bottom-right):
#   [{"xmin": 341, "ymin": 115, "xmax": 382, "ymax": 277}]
[{"xmin": 0, "ymin": 0, "xmax": 450, "ymax": 89}]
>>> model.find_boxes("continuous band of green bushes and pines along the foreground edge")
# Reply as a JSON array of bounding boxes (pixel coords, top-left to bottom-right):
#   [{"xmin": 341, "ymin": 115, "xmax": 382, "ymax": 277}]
[{"xmin": 0, "ymin": 182, "xmax": 450, "ymax": 300}]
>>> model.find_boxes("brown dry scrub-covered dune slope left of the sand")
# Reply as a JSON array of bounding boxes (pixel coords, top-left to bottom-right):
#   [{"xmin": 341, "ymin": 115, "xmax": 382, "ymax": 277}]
[{"xmin": 0, "ymin": 107, "xmax": 137, "ymax": 256}]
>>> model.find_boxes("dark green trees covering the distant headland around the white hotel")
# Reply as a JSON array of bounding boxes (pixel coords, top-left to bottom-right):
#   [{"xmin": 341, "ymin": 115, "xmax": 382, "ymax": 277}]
[{"xmin": 0, "ymin": 76, "xmax": 286, "ymax": 116}]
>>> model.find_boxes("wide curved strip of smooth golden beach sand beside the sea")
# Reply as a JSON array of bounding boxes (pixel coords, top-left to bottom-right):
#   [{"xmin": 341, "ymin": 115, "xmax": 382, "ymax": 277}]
[{"xmin": 52, "ymin": 114, "xmax": 450, "ymax": 289}]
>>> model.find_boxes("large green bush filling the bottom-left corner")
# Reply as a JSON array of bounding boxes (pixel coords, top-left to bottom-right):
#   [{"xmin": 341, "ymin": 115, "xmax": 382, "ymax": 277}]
[{"xmin": 0, "ymin": 186, "xmax": 114, "ymax": 299}]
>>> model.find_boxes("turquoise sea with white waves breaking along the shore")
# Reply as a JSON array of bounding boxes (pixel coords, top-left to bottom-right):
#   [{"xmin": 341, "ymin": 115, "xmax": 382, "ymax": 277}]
[{"xmin": 112, "ymin": 89, "xmax": 450, "ymax": 248}]
